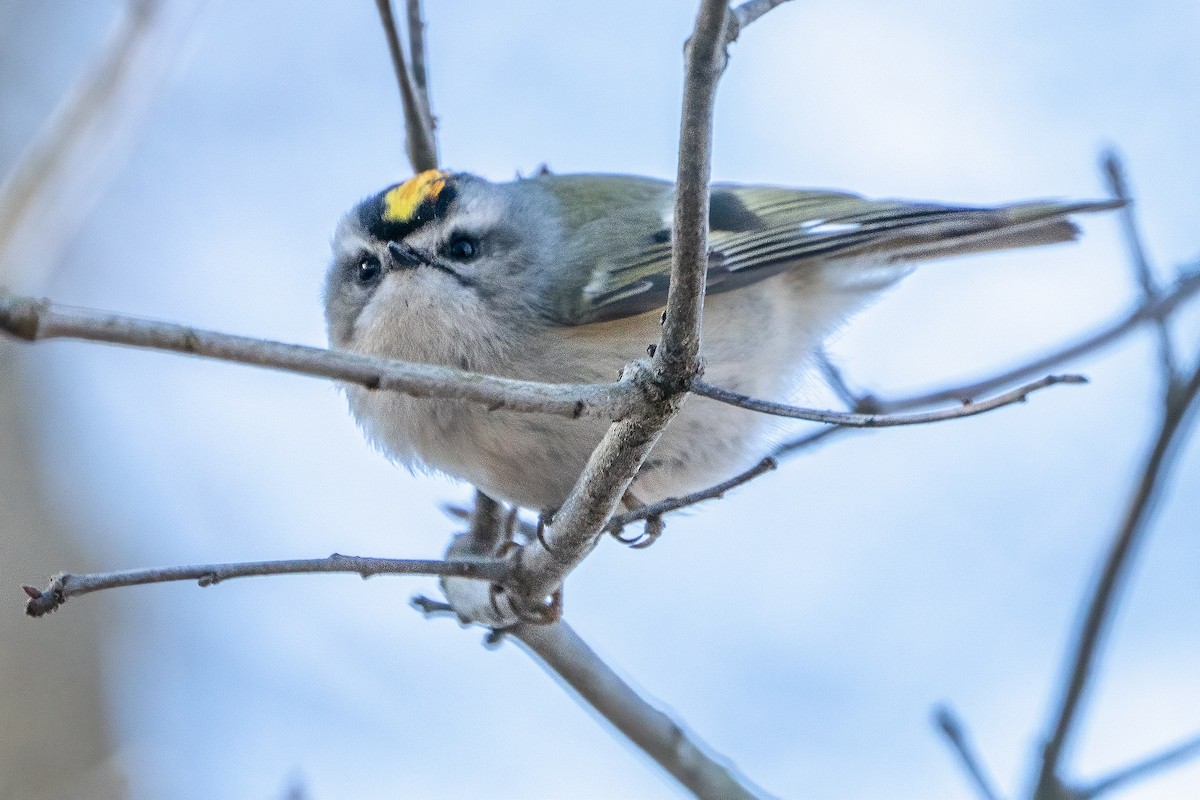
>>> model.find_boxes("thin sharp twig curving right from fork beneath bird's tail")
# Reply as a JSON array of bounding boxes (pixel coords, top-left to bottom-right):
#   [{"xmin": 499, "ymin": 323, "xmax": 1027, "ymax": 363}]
[{"xmin": 691, "ymin": 375, "xmax": 1087, "ymax": 428}]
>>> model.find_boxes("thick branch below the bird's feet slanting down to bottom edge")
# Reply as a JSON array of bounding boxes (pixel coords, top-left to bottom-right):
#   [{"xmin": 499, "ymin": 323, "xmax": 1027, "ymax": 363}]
[{"xmin": 508, "ymin": 622, "xmax": 763, "ymax": 800}]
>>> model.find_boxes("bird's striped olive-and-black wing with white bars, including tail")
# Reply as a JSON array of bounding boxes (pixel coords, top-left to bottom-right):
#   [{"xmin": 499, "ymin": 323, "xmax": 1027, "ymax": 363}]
[{"xmin": 563, "ymin": 185, "xmax": 1120, "ymax": 325}]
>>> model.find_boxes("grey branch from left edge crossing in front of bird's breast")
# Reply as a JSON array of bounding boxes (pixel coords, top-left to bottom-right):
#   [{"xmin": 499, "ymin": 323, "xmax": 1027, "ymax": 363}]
[{"xmin": 0, "ymin": 293, "xmax": 641, "ymax": 420}]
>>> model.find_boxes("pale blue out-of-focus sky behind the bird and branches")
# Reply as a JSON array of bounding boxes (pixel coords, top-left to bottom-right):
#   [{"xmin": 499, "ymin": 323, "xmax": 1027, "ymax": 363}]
[{"xmin": 0, "ymin": 0, "xmax": 1200, "ymax": 800}]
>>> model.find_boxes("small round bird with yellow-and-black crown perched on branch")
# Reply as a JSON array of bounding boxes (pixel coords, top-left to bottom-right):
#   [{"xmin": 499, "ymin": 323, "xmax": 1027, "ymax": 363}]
[{"xmin": 325, "ymin": 170, "xmax": 1114, "ymax": 510}]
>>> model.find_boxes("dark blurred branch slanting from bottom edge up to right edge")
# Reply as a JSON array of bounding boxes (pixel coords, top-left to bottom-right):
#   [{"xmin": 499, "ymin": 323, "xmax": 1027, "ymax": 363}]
[{"xmin": 1033, "ymin": 357, "xmax": 1200, "ymax": 800}]
